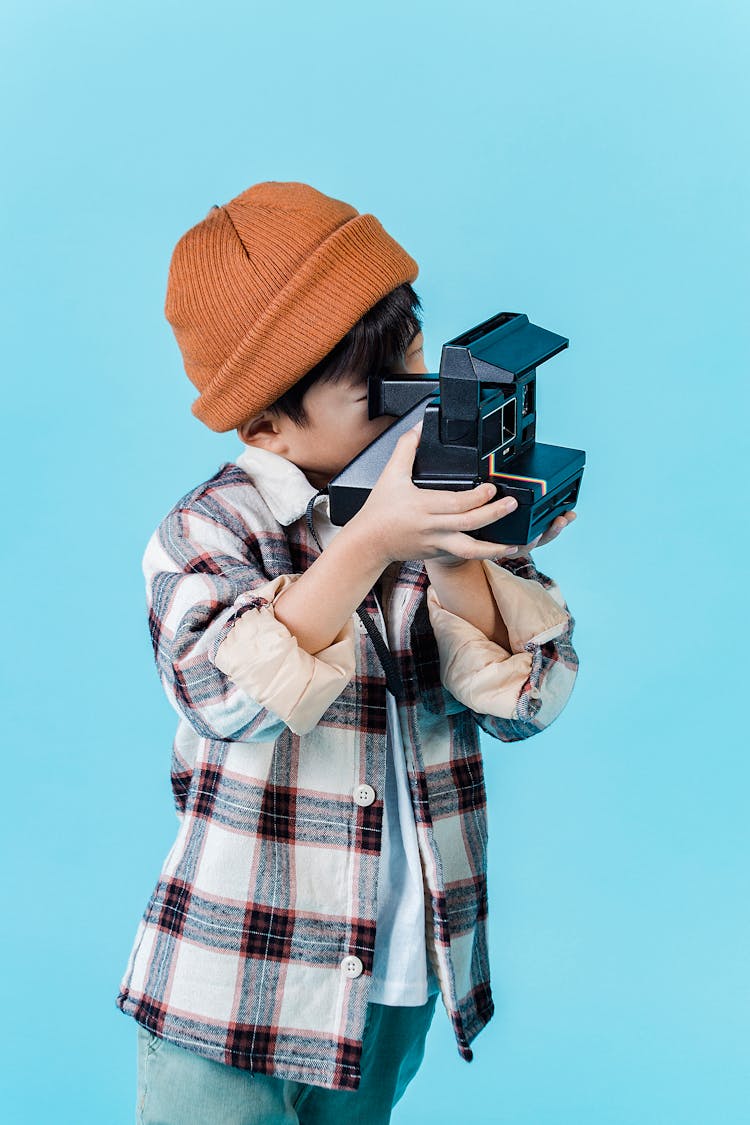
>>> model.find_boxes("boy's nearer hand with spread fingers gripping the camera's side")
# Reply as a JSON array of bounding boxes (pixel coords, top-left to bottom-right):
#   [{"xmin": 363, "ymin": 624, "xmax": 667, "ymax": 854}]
[{"xmin": 351, "ymin": 422, "xmax": 521, "ymax": 569}]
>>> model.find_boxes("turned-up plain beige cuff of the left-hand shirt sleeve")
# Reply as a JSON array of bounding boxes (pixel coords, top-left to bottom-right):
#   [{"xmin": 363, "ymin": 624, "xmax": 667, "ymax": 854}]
[{"xmin": 214, "ymin": 574, "xmax": 355, "ymax": 735}]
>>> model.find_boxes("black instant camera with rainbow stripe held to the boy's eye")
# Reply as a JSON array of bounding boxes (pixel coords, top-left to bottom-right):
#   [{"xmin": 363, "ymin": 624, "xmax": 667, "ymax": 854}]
[{"xmin": 328, "ymin": 313, "xmax": 586, "ymax": 546}]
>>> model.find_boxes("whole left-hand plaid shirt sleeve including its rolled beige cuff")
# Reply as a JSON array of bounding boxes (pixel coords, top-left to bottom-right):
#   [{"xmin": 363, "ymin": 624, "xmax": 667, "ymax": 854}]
[{"xmin": 143, "ymin": 498, "xmax": 354, "ymax": 743}]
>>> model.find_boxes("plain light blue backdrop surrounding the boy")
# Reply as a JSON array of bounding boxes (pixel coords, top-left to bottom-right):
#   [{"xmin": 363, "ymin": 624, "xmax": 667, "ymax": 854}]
[{"xmin": 0, "ymin": 0, "xmax": 750, "ymax": 1125}]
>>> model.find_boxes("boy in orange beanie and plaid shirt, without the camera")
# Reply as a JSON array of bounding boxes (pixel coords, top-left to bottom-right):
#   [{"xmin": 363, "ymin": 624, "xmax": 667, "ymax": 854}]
[{"xmin": 117, "ymin": 181, "xmax": 578, "ymax": 1125}]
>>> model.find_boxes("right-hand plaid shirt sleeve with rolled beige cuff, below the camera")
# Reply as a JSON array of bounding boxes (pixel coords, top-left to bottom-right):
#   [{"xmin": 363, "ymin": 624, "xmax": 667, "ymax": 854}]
[{"xmin": 427, "ymin": 558, "xmax": 578, "ymax": 741}]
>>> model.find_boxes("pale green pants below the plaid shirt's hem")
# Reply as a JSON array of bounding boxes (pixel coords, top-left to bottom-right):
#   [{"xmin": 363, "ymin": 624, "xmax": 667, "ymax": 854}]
[{"xmin": 136, "ymin": 996, "xmax": 437, "ymax": 1125}]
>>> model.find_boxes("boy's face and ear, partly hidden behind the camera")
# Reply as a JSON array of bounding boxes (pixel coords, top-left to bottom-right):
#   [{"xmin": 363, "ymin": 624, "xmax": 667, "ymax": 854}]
[{"xmin": 238, "ymin": 332, "xmax": 427, "ymax": 488}]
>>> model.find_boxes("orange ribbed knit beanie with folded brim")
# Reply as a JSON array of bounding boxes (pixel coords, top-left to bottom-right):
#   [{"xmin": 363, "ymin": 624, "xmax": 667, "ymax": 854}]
[{"xmin": 164, "ymin": 180, "xmax": 418, "ymax": 433}]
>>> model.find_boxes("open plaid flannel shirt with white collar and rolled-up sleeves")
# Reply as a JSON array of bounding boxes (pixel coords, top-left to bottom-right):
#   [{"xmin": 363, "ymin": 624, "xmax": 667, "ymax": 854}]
[{"xmin": 117, "ymin": 462, "xmax": 578, "ymax": 1089}]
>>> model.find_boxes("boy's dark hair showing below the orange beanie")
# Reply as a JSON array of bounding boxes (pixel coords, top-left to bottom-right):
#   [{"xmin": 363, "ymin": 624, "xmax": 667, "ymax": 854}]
[{"xmin": 266, "ymin": 281, "xmax": 422, "ymax": 428}]
